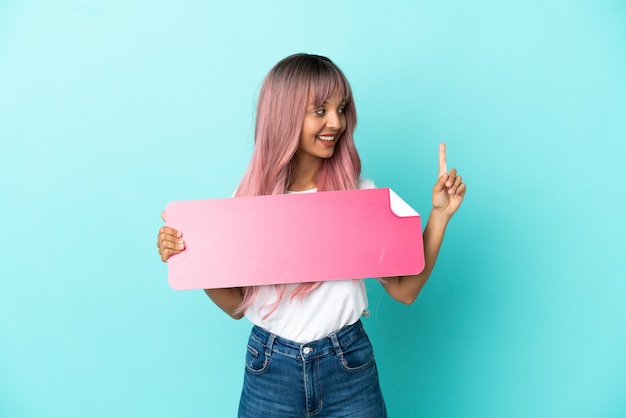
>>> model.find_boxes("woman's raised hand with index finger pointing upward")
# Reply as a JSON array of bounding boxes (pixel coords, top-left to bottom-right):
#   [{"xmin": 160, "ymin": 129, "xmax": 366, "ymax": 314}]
[{"xmin": 433, "ymin": 142, "xmax": 466, "ymax": 217}]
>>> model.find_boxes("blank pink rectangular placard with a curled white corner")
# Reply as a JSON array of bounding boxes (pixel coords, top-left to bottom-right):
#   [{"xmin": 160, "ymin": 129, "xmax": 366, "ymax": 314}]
[{"xmin": 166, "ymin": 189, "xmax": 424, "ymax": 290}]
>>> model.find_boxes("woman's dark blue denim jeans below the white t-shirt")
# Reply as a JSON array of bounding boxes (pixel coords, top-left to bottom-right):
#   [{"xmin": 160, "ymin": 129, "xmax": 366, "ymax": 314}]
[{"xmin": 239, "ymin": 321, "xmax": 387, "ymax": 418}]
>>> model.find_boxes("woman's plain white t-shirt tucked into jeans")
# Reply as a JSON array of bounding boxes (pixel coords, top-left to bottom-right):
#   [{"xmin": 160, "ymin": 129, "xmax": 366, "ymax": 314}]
[{"xmin": 245, "ymin": 179, "xmax": 375, "ymax": 343}]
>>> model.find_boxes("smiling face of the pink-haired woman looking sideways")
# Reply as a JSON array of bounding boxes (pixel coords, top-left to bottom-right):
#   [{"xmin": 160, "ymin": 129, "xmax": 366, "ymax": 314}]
[{"xmin": 298, "ymin": 93, "xmax": 346, "ymax": 162}]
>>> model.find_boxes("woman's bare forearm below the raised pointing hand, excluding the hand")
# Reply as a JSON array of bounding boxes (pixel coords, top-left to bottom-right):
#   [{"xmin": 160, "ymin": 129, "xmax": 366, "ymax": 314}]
[{"xmin": 383, "ymin": 209, "xmax": 450, "ymax": 304}]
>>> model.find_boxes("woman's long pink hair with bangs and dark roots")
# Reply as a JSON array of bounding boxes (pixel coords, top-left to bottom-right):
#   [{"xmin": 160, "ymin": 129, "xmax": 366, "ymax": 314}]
[{"xmin": 235, "ymin": 54, "xmax": 361, "ymax": 317}]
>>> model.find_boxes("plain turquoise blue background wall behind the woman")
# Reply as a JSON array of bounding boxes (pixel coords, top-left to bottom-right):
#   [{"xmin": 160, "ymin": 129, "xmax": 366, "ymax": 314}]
[{"xmin": 0, "ymin": 0, "xmax": 626, "ymax": 418}]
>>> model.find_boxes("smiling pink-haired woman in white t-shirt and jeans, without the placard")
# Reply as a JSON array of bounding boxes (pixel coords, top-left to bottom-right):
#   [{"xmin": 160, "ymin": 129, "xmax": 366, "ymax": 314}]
[{"xmin": 157, "ymin": 54, "xmax": 466, "ymax": 418}]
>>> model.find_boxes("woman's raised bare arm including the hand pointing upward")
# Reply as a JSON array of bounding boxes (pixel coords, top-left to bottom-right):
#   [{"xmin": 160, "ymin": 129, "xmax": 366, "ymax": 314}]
[{"xmin": 381, "ymin": 143, "xmax": 466, "ymax": 304}]
